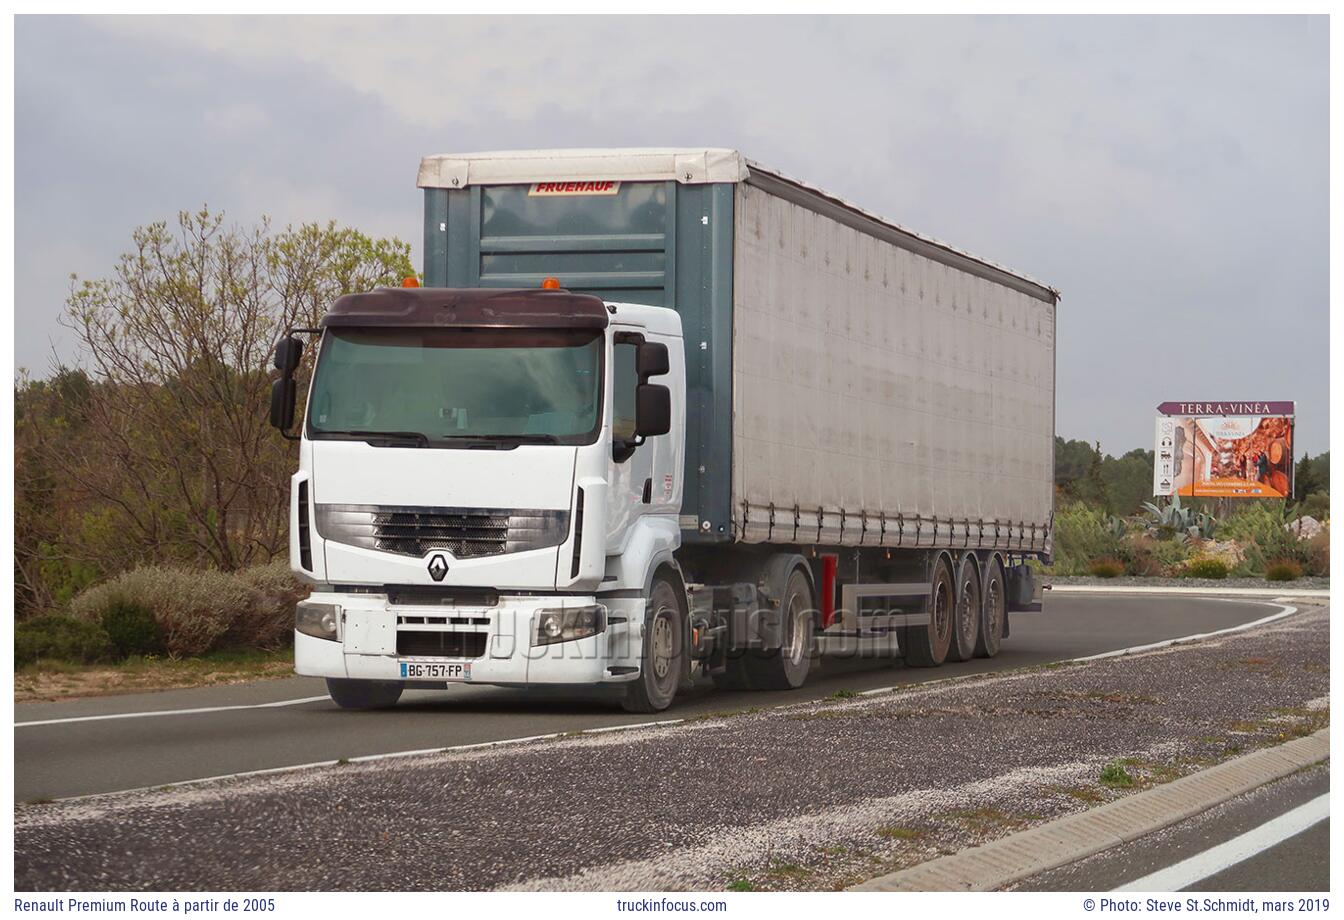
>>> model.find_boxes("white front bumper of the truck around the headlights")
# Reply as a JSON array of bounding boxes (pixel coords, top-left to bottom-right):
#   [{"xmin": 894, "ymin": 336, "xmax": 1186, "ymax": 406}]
[{"xmin": 294, "ymin": 594, "xmax": 644, "ymax": 686}]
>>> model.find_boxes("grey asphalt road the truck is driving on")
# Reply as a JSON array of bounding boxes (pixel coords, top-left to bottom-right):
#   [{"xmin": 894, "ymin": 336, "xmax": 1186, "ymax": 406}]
[{"xmin": 15, "ymin": 594, "xmax": 1275, "ymax": 802}]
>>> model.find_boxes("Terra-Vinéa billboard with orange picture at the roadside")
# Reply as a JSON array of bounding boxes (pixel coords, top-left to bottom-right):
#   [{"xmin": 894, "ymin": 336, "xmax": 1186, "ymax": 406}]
[{"xmin": 1153, "ymin": 400, "xmax": 1294, "ymax": 498}]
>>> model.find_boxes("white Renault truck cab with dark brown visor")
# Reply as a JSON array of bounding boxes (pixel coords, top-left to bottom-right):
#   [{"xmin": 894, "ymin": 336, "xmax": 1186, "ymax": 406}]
[{"xmin": 277, "ymin": 289, "xmax": 685, "ymax": 709}]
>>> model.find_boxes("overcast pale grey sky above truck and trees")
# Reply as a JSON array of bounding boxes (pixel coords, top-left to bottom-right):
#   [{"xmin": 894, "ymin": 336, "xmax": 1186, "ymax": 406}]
[{"xmin": 15, "ymin": 16, "xmax": 1329, "ymax": 454}]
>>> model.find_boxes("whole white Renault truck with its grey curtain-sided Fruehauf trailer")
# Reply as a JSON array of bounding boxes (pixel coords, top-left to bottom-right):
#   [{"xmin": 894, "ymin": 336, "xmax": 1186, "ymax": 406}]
[{"xmin": 271, "ymin": 148, "xmax": 1059, "ymax": 712}]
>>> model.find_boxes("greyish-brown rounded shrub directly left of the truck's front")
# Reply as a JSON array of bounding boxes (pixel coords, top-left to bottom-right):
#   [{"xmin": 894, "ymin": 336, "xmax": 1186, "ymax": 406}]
[{"xmin": 70, "ymin": 565, "xmax": 306, "ymax": 657}]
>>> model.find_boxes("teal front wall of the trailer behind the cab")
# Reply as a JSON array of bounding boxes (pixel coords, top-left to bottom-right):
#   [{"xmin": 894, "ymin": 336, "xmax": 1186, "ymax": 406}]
[{"xmin": 425, "ymin": 180, "xmax": 734, "ymax": 543}]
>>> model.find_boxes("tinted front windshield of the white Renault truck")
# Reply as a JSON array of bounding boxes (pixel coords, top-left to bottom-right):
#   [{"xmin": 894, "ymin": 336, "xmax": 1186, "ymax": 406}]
[{"xmin": 308, "ymin": 329, "xmax": 602, "ymax": 446}]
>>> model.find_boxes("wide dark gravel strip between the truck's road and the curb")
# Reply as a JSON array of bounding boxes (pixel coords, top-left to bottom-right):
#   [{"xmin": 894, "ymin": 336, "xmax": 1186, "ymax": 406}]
[{"xmin": 15, "ymin": 607, "xmax": 1329, "ymax": 890}]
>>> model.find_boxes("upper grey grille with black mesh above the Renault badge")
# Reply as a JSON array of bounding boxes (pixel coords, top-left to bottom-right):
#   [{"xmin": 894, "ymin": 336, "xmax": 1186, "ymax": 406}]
[{"xmin": 317, "ymin": 505, "xmax": 570, "ymax": 559}]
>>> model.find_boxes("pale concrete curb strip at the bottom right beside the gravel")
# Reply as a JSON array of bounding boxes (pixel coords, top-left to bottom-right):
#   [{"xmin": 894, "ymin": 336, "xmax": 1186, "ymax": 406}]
[{"xmin": 848, "ymin": 728, "xmax": 1331, "ymax": 892}]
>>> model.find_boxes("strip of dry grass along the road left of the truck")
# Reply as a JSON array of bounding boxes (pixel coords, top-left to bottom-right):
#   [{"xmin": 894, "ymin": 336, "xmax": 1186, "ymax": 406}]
[{"xmin": 13, "ymin": 649, "xmax": 294, "ymax": 702}]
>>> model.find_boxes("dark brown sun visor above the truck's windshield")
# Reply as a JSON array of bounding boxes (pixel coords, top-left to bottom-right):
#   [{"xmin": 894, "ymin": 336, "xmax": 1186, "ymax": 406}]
[{"xmin": 323, "ymin": 287, "xmax": 607, "ymax": 329}]
